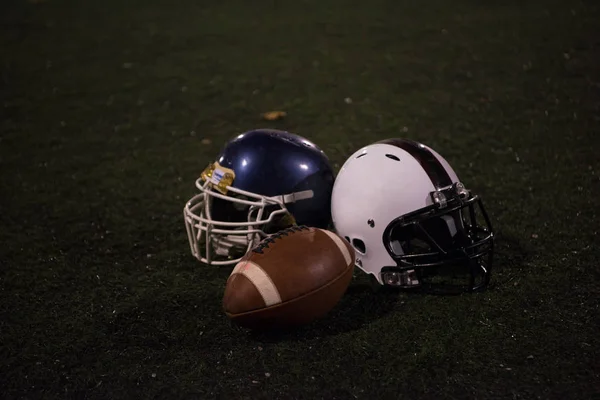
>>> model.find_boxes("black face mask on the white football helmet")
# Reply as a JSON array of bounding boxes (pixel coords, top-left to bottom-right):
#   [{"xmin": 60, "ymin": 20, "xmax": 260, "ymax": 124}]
[{"xmin": 382, "ymin": 196, "xmax": 493, "ymax": 293}]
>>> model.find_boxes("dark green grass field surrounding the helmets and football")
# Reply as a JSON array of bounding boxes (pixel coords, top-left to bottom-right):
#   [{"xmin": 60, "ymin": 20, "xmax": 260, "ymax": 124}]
[{"xmin": 0, "ymin": 0, "xmax": 600, "ymax": 399}]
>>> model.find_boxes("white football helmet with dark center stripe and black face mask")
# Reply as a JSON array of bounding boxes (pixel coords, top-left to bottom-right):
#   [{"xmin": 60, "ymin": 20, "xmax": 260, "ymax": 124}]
[{"xmin": 331, "ymin": 139, "xmax": 493, "ymax": 292}]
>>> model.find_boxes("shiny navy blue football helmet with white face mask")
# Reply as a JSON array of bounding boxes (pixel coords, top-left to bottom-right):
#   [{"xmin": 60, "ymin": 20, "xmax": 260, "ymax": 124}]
[{"xmin": 183, "ymin": 129, "xmax": 335, "ymax": 265}]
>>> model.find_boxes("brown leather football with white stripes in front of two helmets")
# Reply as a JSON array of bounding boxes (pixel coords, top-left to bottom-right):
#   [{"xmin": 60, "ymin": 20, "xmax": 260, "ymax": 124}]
[{"xmin": 223, "ymin": 226, "xmax": 355, "ymax": 330}]
